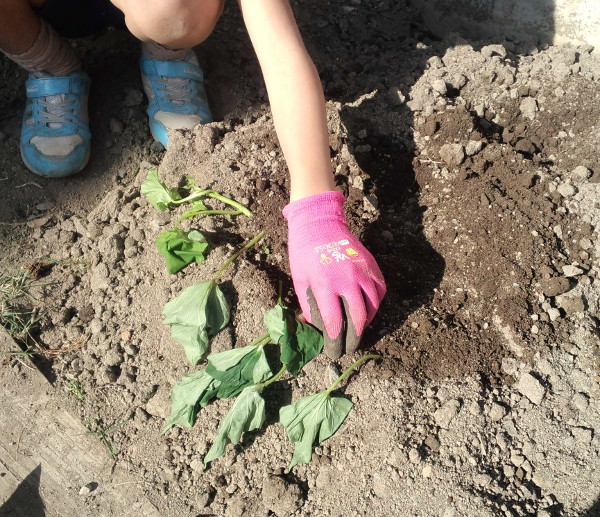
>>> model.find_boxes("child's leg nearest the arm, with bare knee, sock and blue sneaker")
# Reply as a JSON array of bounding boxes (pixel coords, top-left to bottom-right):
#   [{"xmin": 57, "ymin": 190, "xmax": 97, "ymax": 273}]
[{"xmin": 111, "ymin": 0, "xmax": 223, "ymax": 147}]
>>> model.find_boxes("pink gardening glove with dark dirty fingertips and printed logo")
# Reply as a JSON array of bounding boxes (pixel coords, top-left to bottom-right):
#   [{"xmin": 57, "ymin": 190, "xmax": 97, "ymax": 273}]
[{"xmin": 283, "ymin": 191, "xmax": 385, "ymax": 359}]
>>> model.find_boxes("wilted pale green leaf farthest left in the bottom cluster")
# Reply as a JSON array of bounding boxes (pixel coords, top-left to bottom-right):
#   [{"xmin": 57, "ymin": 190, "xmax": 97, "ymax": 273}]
[{"xmin": 160, "ymin": 370, "xmax": 219, "ymax": 435}]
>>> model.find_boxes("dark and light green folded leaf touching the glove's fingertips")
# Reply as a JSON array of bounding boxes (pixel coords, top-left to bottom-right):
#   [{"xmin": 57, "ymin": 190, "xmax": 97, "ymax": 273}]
[{"xmin": 264, "ymin": 305, "xmax": 323, "ymax": 376}]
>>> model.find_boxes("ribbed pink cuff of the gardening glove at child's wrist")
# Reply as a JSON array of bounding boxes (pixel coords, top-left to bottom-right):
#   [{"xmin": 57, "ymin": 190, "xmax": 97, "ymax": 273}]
[{"xmin": 283, "ymin": 190, "xmax": 346, "ymax": 226}]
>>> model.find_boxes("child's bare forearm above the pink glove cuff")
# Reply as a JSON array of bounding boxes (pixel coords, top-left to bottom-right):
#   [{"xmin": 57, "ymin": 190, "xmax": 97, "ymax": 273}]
[{"xmin": 239, "ymin": 0, "xmax": 335, "ymax": 201}]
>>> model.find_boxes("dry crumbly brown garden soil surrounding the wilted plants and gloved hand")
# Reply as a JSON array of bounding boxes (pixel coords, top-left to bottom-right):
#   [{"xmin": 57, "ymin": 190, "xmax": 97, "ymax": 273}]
[{"xmin": 0, "ymin": 0, "xmax": 600, "ymax": 517}]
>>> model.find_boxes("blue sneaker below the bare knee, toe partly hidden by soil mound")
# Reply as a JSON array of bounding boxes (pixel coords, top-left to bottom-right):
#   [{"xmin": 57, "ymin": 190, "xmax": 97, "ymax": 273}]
[{"xmin": 140, "ymin": 51, "xmax": 212, "ymax": 147}]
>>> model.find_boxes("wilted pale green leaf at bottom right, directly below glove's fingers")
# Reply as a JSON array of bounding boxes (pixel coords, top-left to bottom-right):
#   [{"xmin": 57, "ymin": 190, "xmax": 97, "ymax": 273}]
[{"xmin": 279, "ymin": 391, "xmax": 353, "ymax": 472}]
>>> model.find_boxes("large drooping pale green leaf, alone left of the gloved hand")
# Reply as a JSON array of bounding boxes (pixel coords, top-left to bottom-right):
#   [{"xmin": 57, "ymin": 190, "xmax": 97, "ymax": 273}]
[{"xmin": 163, "ymin": 280, "xmax": 229, "ymax": 364}]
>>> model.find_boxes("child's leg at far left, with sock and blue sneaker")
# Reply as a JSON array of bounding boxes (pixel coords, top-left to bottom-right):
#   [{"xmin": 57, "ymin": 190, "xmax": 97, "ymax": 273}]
[{"xmin": 0, "ymin": 0, "xmax": 90, "ymax": 177}]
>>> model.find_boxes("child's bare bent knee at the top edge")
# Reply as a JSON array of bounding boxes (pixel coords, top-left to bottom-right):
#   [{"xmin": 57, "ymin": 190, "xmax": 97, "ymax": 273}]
[{"xmin": 112, "ymin": 0, "xmax": 224, "ymax": 48}]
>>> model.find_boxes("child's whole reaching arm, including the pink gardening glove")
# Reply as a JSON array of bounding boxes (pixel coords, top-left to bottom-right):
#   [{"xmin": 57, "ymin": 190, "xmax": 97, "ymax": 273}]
[{"xmin": 238, "ymin": 0, "xmax": 385, "ymax": 358}]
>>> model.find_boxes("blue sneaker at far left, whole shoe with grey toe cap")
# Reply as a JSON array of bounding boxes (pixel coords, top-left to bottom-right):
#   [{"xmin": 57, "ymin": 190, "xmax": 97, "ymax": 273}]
[{"xmin": 20, "ymin": 72, "xmax": 91, "ymax": 178}]
